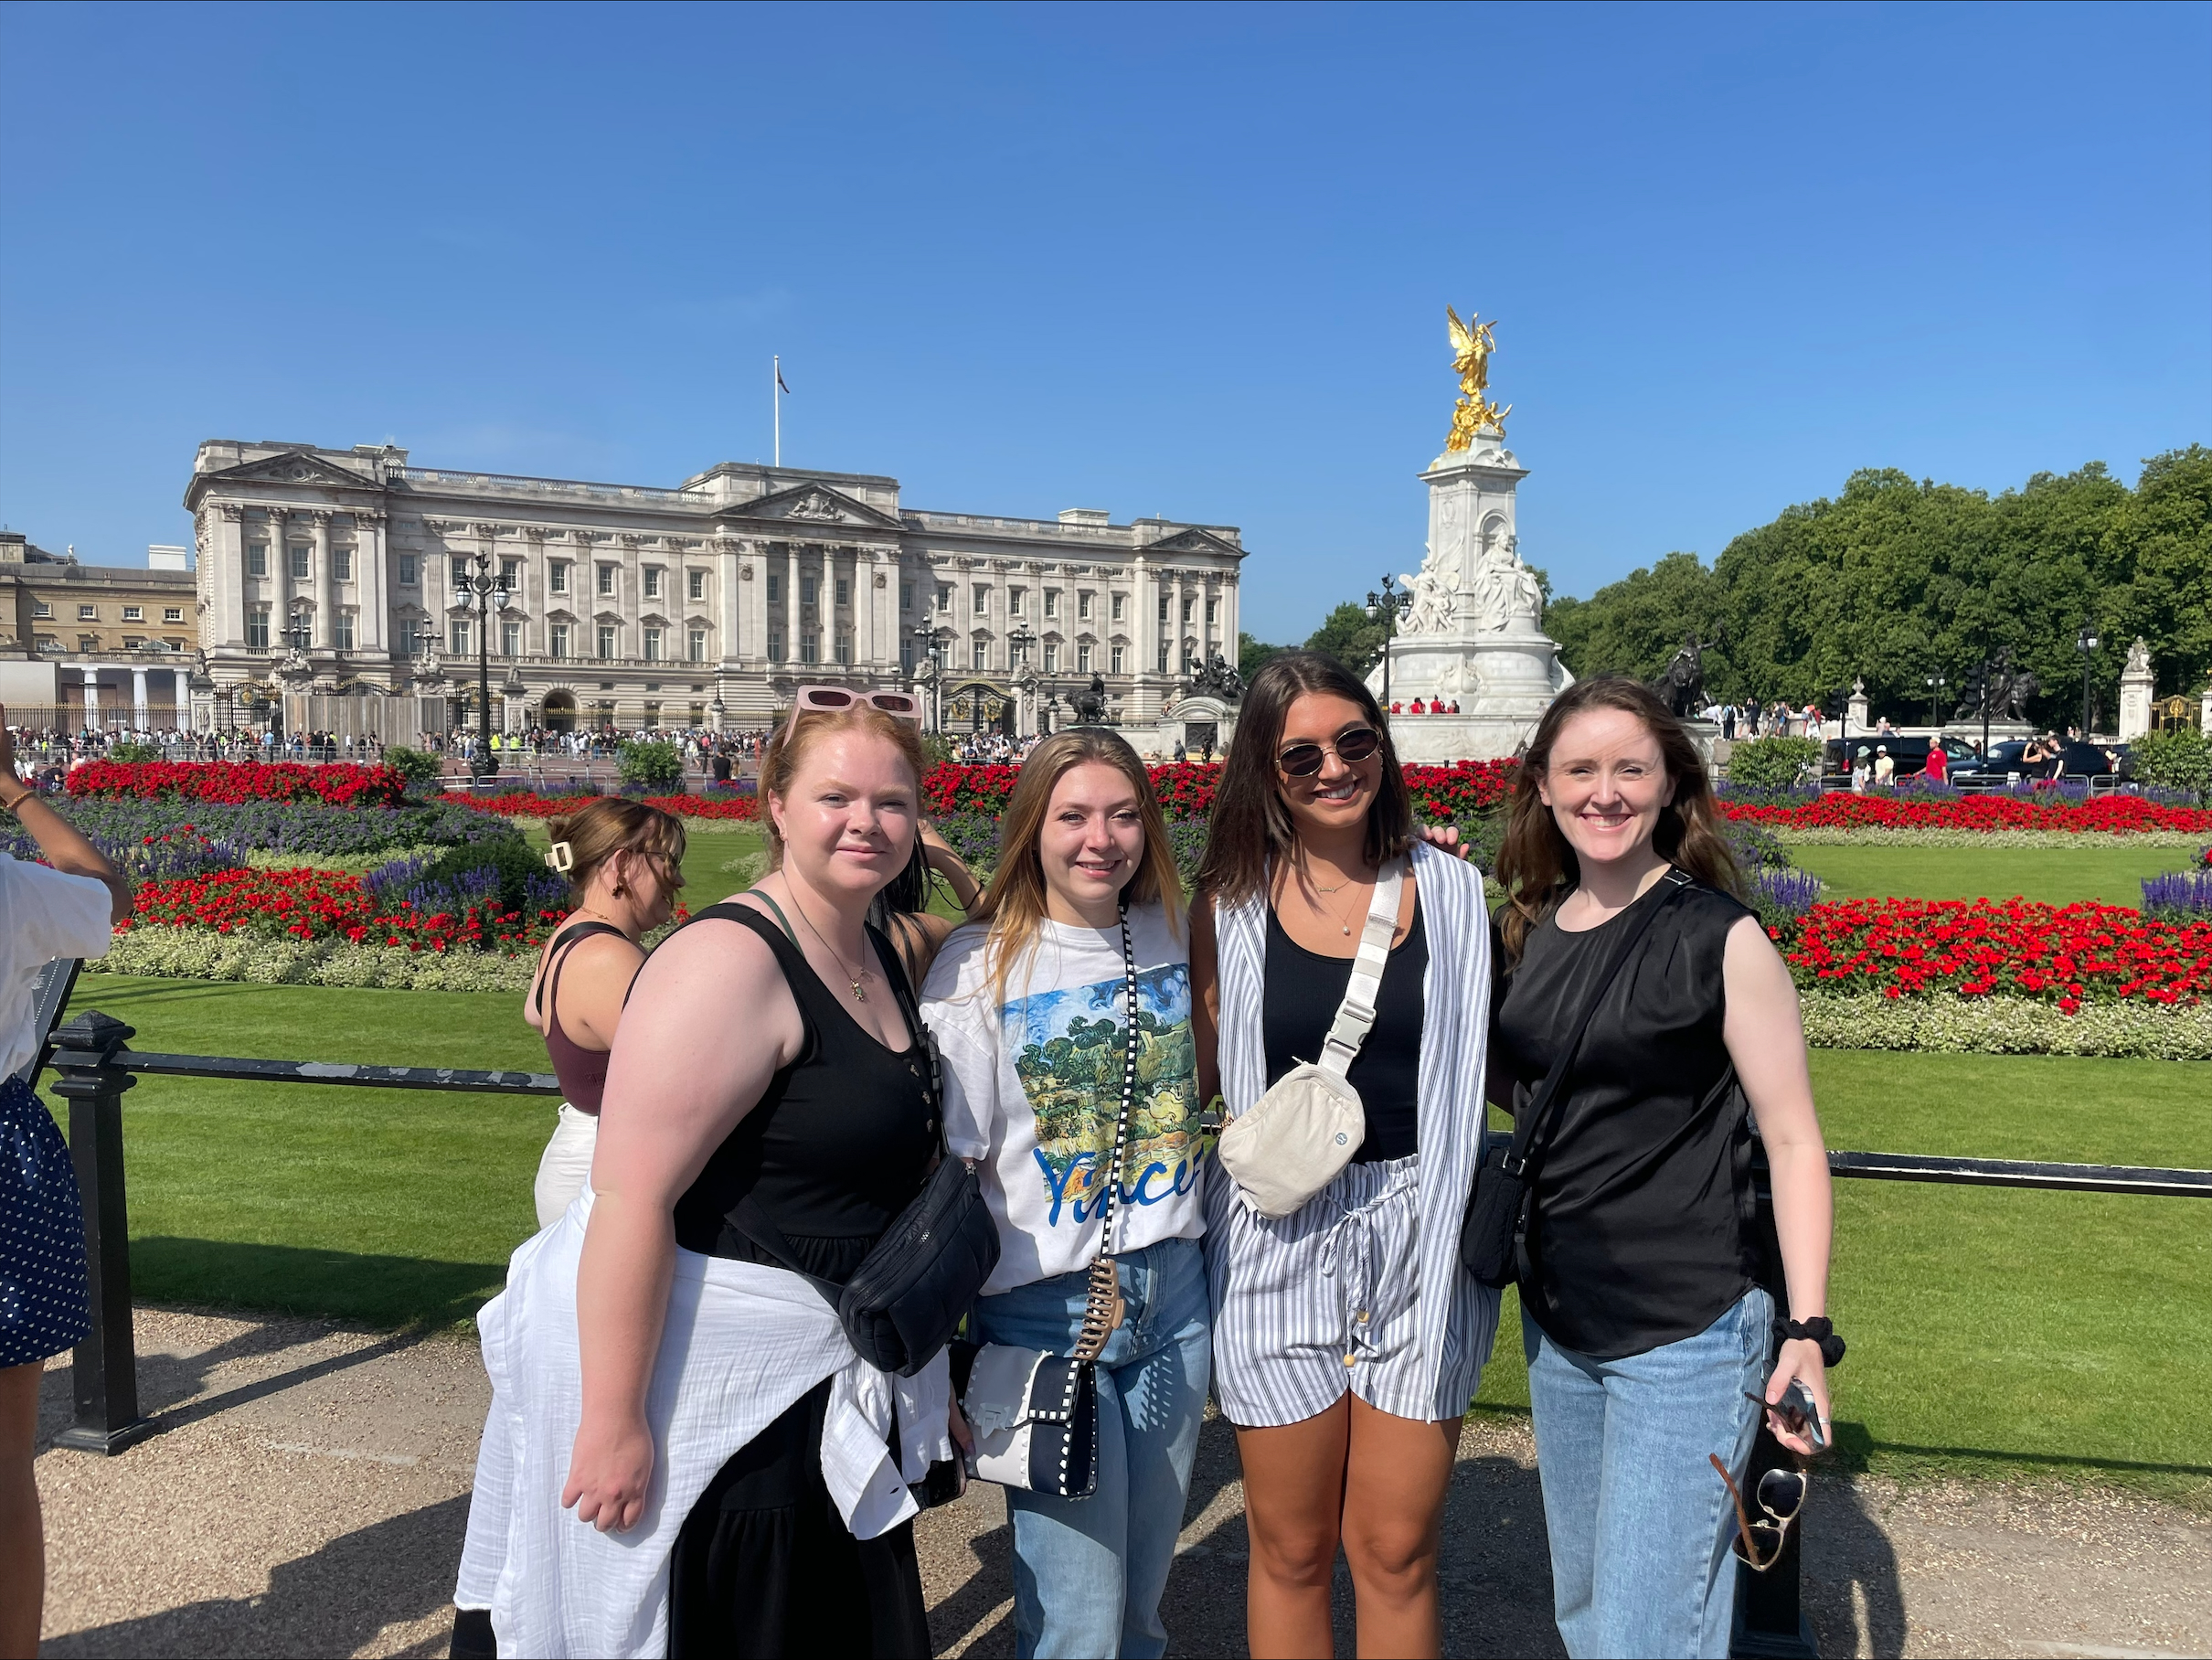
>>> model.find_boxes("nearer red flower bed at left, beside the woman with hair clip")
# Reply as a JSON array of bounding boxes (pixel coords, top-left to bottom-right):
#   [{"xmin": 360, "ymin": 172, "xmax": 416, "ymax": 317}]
[{"xmin": 120, "ymin": 870, "xmax": 567, "ymax": 956}]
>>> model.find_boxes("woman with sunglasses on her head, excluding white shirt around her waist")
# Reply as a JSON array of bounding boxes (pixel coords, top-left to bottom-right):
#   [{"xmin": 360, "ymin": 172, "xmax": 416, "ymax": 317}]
[{"xmin": 564, "ymin": 704, "xmax": 938, "ymax": 1655}]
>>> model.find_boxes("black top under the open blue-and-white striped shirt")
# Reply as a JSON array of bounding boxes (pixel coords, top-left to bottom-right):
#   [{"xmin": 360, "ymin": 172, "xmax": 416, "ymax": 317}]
[{"xmin": 1260, "ymin": 894, "xmax": 1429, "ymax": 1165}]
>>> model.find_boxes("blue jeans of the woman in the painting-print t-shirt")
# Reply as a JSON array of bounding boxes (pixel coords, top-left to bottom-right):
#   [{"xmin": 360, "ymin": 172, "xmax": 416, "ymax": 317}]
[{"xmin": 973, "ymin": 1240, "xmax": 1212, "ymax": 1660}]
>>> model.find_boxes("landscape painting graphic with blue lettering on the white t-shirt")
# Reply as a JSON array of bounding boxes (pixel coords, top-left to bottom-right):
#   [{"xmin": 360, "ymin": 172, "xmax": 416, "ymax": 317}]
[{"xmin": 997, "ymin": 963, "xmax": 1206, "ymax": 1229}]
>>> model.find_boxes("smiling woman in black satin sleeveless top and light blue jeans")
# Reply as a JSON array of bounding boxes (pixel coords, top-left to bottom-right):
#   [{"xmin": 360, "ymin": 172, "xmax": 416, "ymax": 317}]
[{"xmin": 1491, "ymin": 676, "xmax": 1829, "ymax": 1658}]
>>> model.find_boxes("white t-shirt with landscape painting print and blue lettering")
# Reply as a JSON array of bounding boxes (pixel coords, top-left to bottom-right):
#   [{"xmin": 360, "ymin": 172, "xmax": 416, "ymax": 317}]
[{"xmin": 922, "ymin": 905, "xmax": 1212, "ymax": 1297}]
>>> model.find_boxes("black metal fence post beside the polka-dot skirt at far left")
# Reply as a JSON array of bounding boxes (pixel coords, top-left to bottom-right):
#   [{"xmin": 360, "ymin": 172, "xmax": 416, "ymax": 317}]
[{"xmin": 53, "ymin": 1009, "xmax": 157, "ymax": 1454}]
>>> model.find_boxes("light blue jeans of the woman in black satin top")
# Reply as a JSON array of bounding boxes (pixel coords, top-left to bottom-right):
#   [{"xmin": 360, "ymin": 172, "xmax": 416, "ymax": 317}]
[{"xmin": 1522, "ymin": 1288, "xmax": 1774, "ymax": 1660}]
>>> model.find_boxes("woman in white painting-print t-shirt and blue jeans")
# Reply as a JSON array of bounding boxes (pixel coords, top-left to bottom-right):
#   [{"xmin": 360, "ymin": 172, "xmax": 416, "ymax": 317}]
[{"xmin": 922, "ymin": 729, "xmax": 1210, "ymax": 1660}]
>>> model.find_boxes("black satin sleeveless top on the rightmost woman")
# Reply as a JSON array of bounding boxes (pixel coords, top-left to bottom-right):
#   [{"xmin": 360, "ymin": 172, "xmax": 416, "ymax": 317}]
[{"xmin": 1491, "ymin": 883, "xmax": 1759, "ymax": 1359}]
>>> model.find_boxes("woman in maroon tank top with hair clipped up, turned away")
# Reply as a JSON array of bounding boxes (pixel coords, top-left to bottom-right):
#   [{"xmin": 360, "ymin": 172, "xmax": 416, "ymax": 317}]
[{"xmin": 522, "ymin": 797, "xmax": 684, "ymax": 1229}]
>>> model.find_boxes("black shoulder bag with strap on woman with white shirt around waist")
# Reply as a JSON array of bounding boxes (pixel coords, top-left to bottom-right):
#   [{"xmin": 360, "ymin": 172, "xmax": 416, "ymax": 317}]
[{"xmin": 692, "ymin": 894, "xmax": 997, "ymax": 1377}]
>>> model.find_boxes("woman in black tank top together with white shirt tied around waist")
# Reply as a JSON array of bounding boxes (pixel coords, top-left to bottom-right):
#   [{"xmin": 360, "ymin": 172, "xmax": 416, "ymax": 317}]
[{"xmin": 456, "ymin": 699, "xmax": 953, "ymax": 1660}]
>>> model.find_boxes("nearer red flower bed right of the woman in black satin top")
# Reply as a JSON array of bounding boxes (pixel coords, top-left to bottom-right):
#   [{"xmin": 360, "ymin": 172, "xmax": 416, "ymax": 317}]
[{"xmin": 1771, "ymin": 899, "xmax": 2212, "ymax": 1014}]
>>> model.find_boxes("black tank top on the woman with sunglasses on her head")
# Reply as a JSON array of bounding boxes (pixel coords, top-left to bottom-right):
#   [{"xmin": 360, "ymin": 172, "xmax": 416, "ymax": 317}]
[{"xmin": 675, "ymin": 900, "xmax": 938, "ymax": 1283}]
